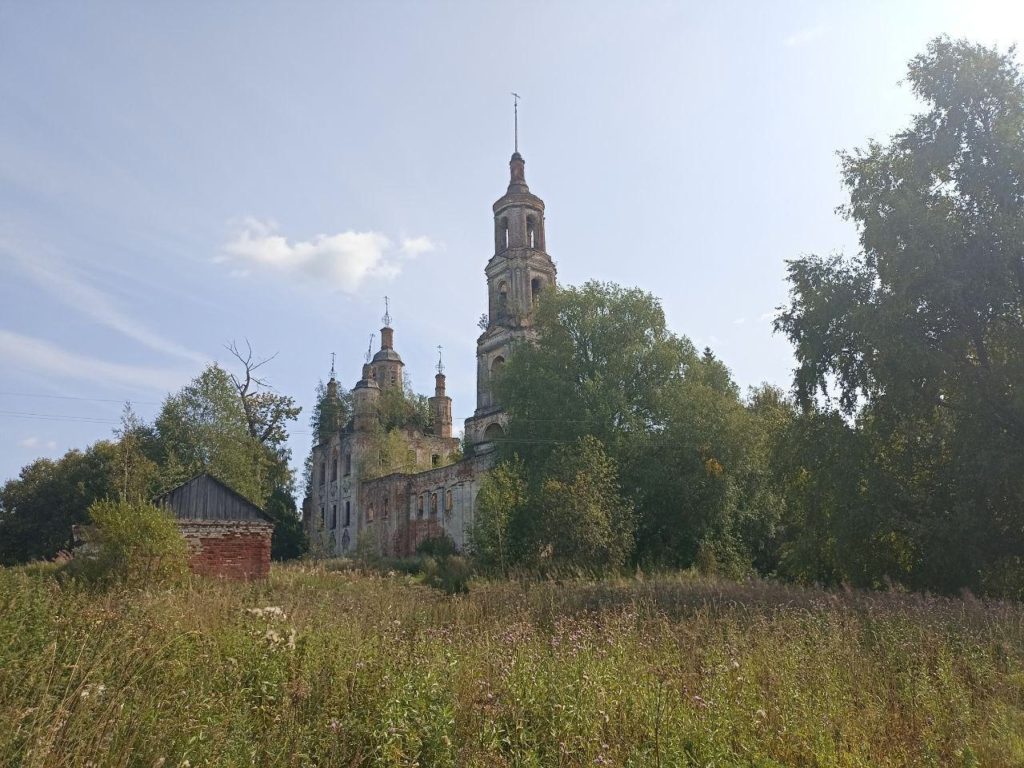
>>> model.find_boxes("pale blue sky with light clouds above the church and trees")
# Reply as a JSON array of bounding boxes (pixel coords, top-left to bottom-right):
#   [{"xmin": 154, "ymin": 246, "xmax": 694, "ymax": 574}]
[{"xmin": 0, "ymin": 0, "xmax": 1024, "ymax": 481}]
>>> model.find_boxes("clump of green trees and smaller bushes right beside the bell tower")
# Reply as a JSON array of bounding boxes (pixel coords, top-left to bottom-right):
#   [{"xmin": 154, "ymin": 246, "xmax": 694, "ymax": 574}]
[{"xmin": 489, "ymin": 283, "xmax": 790, "ymax": 570}]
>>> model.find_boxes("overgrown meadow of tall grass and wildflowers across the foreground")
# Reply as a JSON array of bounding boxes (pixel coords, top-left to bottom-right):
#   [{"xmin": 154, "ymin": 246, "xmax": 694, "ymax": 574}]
[{"xmin": 0, "ymin": 565, "xmax": 1024, "ymax": 767}]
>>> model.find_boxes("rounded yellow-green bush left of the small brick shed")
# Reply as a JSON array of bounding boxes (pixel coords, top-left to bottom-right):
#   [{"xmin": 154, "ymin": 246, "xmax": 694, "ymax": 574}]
[{"xmin": 69, "ymin": 501, "xmax": 188, "ymax": 587}]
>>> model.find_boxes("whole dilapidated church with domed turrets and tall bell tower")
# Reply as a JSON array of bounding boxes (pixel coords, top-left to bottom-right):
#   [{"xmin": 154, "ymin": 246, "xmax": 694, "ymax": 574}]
[{"xmin": 302, "ymin": 151, "xmax": 557, "ymax": 556}]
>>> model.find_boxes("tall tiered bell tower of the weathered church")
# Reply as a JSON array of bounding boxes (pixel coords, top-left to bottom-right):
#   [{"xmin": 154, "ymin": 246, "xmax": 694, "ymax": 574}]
[{"xmin": 466, "ymin": 138, "xmax": 556, "ymax": 451}]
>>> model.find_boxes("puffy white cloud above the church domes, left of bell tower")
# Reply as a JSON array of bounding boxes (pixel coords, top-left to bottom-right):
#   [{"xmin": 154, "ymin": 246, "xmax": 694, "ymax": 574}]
[{"xmin": 217, "ymin": 218, "xmax": 436, "ymax": 293}]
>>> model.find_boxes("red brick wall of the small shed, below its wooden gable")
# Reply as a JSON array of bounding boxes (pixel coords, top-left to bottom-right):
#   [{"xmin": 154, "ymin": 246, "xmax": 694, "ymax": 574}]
[{"xmin": 179, "ymin": 520, "xmax": 273, "ymax": 579}]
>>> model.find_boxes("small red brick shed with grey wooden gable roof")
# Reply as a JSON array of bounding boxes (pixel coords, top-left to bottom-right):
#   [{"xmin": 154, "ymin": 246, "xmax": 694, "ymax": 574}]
[{"xmin": 156, "ymin": 473, "xmax": 273, "ymax": 579}]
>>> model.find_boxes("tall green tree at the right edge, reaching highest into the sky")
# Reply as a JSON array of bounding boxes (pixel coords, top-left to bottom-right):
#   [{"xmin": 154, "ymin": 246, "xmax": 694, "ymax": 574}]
[{"xmin": 776, "ymin": 38, "xmax": 1024, "ymax": 590}]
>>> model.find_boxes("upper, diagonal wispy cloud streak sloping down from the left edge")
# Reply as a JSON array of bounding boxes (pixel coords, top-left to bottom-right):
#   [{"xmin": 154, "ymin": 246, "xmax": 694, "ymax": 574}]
[{"xmin": 0, "ymin": 241, "xmax": 206, "ymax": 362}]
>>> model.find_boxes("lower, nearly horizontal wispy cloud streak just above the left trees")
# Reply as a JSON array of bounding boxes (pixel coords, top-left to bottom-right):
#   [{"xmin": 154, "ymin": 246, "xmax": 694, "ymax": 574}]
[{"xmin": 0, "ymin": 330, "xmax": 189, "ymax": 391}]
